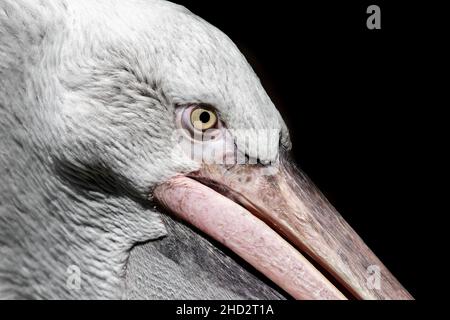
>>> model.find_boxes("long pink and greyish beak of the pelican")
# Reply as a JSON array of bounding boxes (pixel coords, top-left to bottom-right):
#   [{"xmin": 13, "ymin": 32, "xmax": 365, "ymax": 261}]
[{"xmin": 154, "ymin": 151, "xmax": 413, "ymax": 300}]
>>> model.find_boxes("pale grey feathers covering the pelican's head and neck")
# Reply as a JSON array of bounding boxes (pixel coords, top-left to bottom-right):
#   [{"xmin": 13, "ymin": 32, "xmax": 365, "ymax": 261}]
[{"xmin": 0, "ymin": 0, "xmax": 290, "ymax": 299}]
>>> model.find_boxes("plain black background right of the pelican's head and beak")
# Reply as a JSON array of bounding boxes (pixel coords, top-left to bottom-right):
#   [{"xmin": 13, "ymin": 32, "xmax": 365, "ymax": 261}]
[{"xmin": 176, "ymin": 0, "xmax": 438, "ymax": 299}]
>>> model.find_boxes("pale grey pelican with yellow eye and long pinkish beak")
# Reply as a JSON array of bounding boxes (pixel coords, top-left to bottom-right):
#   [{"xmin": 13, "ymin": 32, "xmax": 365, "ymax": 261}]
[{"xmin": 0, "ymin": 0, "xmax": 412, "ymax": 300}]
